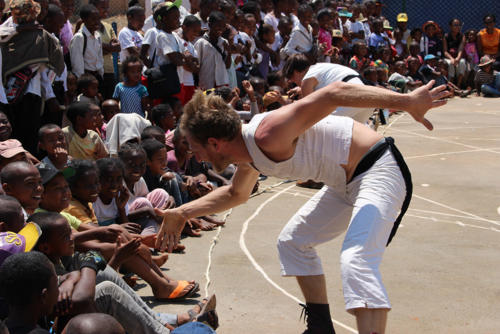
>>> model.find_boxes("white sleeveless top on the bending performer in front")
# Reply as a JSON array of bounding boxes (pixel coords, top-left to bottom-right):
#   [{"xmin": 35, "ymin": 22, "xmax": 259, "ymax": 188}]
[{"xmin": 242, "ymin": 113, "xmax": 353, "ymax": 189}]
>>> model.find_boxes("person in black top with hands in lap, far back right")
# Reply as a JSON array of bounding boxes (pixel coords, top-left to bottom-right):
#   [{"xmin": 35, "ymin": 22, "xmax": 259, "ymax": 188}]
[{"xmin": 443, "ymin": 19, "xmax": 467, "ymax": 88}]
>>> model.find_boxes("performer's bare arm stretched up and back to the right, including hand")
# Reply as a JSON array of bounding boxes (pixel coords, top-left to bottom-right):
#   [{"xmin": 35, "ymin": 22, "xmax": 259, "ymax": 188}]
[{"xmin": 256, "ymin": 81, "xmax": 449, "ymax": 155}]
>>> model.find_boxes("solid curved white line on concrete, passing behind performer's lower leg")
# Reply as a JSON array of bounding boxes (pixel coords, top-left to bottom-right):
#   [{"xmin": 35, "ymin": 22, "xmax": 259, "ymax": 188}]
[{"xmin": 240, "ymin": 183, "xmax": 358, "ymax": 333}]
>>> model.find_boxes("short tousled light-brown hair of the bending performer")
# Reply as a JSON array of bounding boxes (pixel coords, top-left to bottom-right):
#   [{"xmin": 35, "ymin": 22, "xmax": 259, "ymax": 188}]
[{"xmin": 180, "ymin": 90, "xmax": 241, "ymax": 144}]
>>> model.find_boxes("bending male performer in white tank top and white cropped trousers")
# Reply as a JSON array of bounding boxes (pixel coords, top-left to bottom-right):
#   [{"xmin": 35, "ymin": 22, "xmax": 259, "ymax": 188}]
[{"xmin": 156, "ymin": 82, "xmax": 449, "ymax": 334}]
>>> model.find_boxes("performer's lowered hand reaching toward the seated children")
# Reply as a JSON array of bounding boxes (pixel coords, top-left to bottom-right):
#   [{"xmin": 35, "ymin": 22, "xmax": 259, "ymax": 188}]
[{"xmin": 155, "ymin": 209, "xmax": 186, "ymax": 253}]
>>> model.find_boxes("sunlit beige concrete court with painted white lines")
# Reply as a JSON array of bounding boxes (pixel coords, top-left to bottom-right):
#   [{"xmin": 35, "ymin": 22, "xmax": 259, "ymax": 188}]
[{"xmin": 140, "ymin": 97, "xmax": 500, "ymax": 334}]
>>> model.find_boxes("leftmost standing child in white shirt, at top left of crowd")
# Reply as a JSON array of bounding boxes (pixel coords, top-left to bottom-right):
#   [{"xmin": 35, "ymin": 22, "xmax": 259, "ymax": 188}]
[{"xmin": 70, "ymin": 5, "xmax": 104, "ymax": 82}]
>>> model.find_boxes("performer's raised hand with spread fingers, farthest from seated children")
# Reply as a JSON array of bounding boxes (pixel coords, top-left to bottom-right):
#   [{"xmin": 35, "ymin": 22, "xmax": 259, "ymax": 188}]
[{"xmin": 406, "ymin": 80, "xmax": 451, "ymax": 130}]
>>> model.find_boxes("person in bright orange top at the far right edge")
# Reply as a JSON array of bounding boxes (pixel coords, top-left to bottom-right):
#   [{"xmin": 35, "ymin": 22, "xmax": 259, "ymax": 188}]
[{"xmin": 477, "ymin": 14, "xmax": 500, "ymax": 71}]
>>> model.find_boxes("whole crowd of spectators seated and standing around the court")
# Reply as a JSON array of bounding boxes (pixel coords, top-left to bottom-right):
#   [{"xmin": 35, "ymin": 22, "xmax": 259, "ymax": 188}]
[{"xmin": 0, "ymin": 0, "xmax": 500, "ymax": 333}]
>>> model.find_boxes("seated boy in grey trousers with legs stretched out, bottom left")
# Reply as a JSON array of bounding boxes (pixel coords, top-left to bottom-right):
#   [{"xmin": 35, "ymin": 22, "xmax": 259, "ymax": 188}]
[{"xmin": 32, "ymin": 212, "xmax": 215, "ymax": 333}]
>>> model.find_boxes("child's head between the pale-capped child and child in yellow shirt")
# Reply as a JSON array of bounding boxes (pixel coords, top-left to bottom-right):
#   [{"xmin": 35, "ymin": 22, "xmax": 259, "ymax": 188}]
[{"xmin": 38, "ymin": 124, "xmax": 69, "ymax": 170}]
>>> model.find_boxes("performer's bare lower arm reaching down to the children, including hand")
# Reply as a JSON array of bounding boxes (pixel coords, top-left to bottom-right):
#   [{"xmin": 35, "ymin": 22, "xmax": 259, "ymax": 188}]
[{"xmin": 155, "ymin": 164, "xmax": 259, "ymax": 252}]
